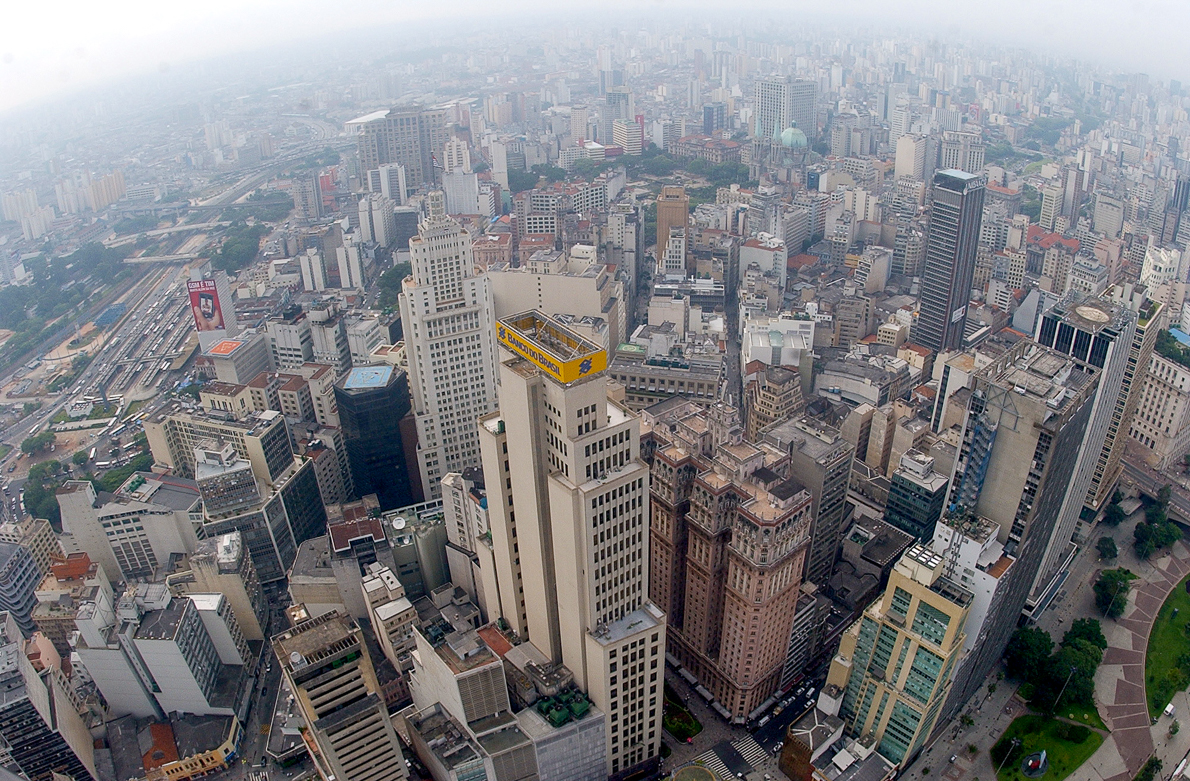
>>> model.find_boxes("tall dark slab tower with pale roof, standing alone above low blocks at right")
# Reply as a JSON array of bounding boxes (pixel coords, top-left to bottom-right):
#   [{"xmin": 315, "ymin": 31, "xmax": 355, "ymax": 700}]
[{"xmin": 913, "ymin": 169, "xmax": 988, "ymax": 352}]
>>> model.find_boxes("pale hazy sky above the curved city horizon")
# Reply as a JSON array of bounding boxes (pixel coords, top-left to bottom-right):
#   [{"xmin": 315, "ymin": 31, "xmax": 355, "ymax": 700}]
[{"xmin": 0, "ymin": 0, "xmax": 1190, "ymax": 111}]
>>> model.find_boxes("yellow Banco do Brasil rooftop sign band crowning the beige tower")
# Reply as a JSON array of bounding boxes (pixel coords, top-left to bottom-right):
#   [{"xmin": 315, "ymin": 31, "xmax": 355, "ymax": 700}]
[{"xmin": 496, "ymin": 311, "xmax": 607, "ymax": 385}]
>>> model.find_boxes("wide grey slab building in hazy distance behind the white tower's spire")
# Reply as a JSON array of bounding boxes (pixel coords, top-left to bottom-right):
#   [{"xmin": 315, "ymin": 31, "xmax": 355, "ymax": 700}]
[{"xmin": 346, "ymin": 106, "xmax": 450, "ymax": 190}]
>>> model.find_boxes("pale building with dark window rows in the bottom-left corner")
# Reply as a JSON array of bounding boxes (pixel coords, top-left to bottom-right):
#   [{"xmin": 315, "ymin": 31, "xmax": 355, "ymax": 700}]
[{"xmin": 0, "ymin": 612, "xmax": 99, "ymax": 781}]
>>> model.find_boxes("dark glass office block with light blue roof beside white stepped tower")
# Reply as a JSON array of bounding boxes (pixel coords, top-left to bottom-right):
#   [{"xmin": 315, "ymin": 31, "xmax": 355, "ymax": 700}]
[{"xmin": 334, "ymin": 365, "xmax": 413, "ymax": 510}]
